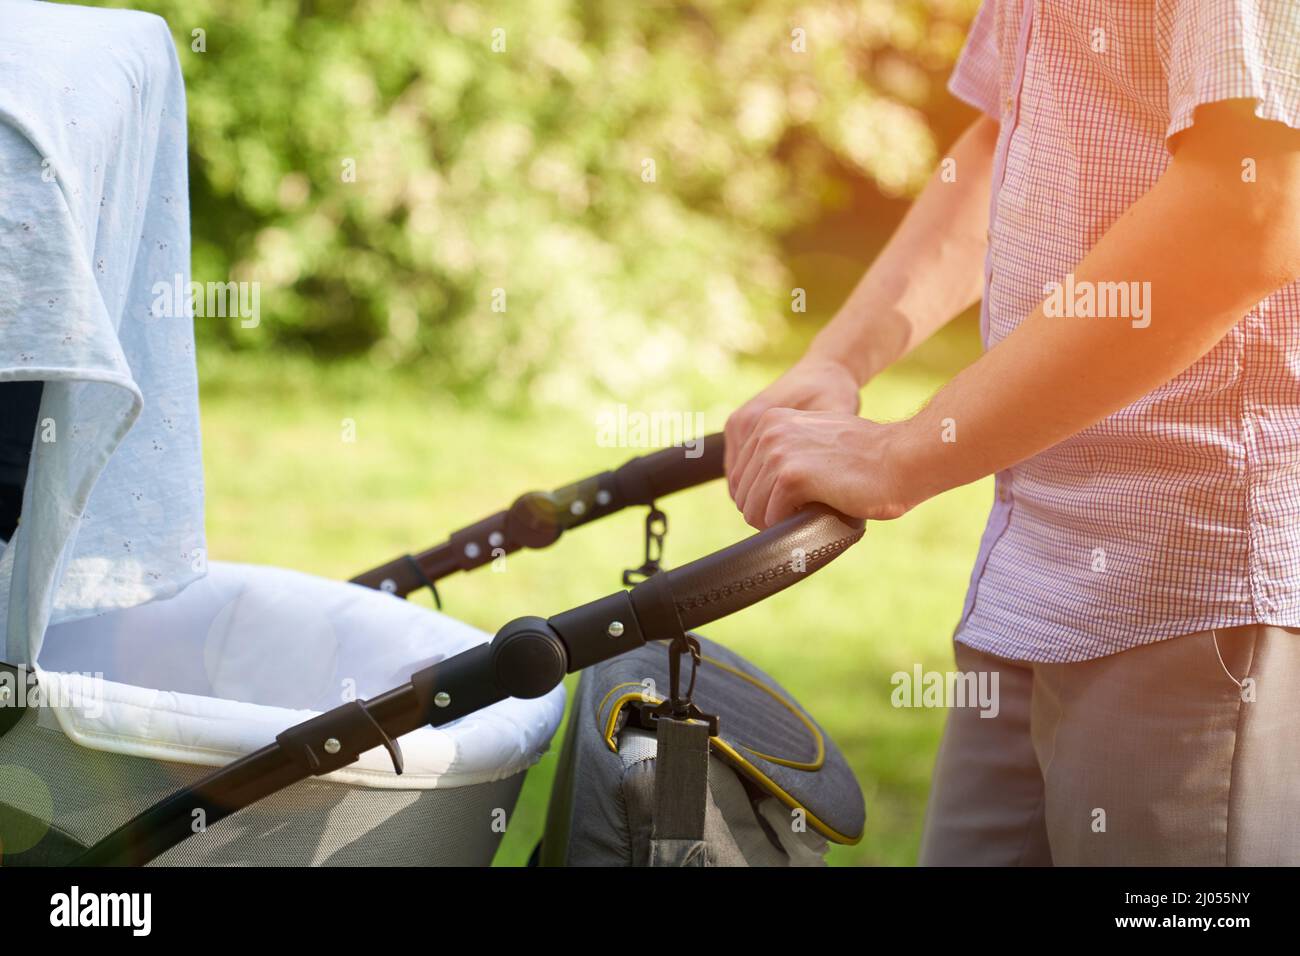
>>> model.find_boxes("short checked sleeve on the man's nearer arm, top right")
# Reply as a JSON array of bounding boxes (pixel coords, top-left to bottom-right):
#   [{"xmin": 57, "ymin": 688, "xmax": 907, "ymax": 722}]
[{"xmin": 1165, "ymin": 0, "xmax": 1300, "ymax": 139}]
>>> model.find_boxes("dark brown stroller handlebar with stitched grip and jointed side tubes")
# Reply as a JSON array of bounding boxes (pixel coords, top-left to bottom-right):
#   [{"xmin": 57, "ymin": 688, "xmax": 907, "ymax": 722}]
[{"xmin": 74, "ymin": 434, "xmax": 863, "ymax": 866}]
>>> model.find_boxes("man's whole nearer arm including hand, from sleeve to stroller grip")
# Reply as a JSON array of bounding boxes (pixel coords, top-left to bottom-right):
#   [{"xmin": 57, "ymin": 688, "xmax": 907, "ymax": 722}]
[{"xmin": 733, "ymin": 101, "xmax": 1300, "ymax": 527}]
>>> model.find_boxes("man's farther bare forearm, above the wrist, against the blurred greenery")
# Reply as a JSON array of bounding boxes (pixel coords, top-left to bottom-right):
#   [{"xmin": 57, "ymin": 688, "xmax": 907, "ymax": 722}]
[{"xmin": 809, "ymin": 117, "xmax": 997, "ymax": 382}]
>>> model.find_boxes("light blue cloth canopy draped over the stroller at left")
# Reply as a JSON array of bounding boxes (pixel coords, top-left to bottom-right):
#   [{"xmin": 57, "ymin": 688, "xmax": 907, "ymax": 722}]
[{"xmin": 0, "ymin": 0, "xmax": 204, "ymax": 663}]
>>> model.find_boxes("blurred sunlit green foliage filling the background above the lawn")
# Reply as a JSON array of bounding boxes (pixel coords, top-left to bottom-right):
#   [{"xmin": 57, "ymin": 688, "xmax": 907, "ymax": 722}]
[{"xmin": 96, "ymin": 0, "xmax": 976, "ymax": 403}]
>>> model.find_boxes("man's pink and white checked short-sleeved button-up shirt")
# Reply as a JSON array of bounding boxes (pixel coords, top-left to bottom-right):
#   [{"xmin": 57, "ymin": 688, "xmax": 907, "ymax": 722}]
[{"xmin": 949, "ymin": 0, "xmax": 1300, "ymax": 661}]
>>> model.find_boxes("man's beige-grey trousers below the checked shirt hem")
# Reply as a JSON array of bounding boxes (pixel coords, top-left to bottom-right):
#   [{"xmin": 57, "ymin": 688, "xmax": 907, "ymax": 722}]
[{"xmin": 920, "ymin": 626, "xmax": 1300, "ymax": 866}]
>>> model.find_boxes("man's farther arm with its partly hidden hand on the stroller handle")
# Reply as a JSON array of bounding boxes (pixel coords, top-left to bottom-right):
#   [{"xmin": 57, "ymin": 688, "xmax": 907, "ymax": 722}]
[{"xmin": 727, "ymin": 116, "xmax": 997, "ymax": 475}]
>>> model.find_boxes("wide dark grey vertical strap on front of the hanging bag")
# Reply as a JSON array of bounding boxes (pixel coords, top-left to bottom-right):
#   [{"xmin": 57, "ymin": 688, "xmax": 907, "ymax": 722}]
[{"xmin": 650, "ymin": 715, "xmax": 709, "ymax": 866}]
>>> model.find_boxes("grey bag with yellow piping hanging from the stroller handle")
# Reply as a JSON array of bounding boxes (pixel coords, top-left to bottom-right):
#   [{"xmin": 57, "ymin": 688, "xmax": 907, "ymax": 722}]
[{"xmin": 540, "ymin": 635, "xmax": 866, "ymax": 866}]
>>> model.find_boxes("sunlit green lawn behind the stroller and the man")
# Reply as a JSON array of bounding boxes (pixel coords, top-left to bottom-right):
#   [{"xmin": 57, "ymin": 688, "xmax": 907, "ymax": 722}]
[{"xmin": 202, "ymin": 323, "xmax": 989, "ymax": 865}]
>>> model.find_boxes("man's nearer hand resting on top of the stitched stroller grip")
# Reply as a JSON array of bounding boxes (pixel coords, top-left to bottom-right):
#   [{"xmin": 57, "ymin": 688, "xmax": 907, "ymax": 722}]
[{"xmin": 728, "ymin": 408, "xmax": 924, "ymax": 529}]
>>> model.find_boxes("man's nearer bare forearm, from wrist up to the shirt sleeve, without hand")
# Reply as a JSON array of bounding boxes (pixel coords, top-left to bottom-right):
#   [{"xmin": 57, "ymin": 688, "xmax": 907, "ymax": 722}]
[{"xmin": 900, "ymin": 109, "xmax": 1300, "ymax": 498}]
